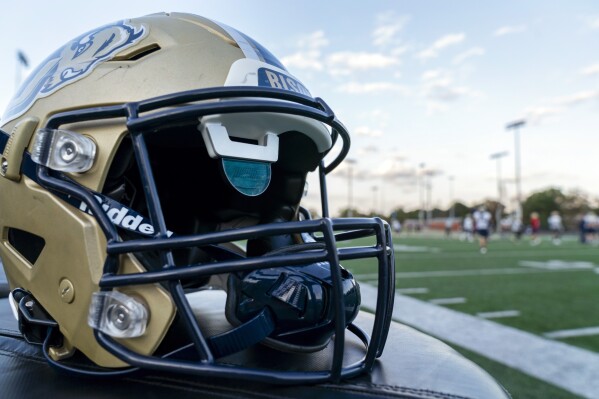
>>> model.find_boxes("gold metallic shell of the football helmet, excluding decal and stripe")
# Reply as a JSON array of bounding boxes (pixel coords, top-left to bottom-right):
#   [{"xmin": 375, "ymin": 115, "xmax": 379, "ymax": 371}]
[{"xmin": 0, "ymin": 13, "xmax": 243, "ymax": 367}]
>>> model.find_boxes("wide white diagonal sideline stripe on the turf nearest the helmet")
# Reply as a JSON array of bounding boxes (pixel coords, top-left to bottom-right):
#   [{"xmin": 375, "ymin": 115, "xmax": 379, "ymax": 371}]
[{"xmin": 360, "ymin": 284, "xmax": 599, "ymax": 398}]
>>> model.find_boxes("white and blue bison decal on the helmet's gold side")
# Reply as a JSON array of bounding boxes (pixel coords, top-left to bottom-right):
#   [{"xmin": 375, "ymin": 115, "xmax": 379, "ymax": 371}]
[{"xmin": 2, "ymin": 21, "xmax": 148, "ymax": 123}]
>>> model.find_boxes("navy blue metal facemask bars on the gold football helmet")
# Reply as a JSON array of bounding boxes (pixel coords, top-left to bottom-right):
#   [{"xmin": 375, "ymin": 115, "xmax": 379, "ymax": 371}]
[{"xmin": 32, "ymin": 87, "xmax": 395, "ymax": 383}]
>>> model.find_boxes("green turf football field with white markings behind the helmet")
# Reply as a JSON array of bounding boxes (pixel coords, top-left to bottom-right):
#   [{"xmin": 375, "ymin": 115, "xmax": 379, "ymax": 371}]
[{"xmin": 347, "ymin": 234, "xmax": 599, "ymax": 398}]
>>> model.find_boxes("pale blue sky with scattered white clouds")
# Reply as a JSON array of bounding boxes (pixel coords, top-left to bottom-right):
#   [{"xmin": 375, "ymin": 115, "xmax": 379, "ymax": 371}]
[{"xmin": 0, "ymin": 0, "xmax": 599, "ymax": 214}]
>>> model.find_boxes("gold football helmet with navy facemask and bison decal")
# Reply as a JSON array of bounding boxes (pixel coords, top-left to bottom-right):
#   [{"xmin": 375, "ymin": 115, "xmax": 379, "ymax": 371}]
[{"xmin": 0, "ymin": 13, "xmax": 394, "ymax": 383}]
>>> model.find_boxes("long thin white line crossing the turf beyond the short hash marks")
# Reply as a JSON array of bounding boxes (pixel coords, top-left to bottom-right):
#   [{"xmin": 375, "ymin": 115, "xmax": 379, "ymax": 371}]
[{"xmin": 354, "ymin": 267, "xmax": 599, "ymax": 280}]
